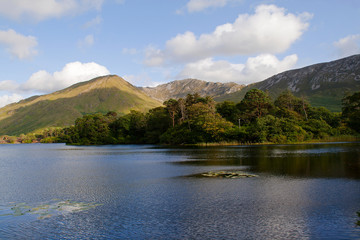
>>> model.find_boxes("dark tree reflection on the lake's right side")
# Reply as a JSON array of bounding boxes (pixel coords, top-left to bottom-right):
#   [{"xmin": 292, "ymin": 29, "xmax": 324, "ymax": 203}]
[{"xmin": 172, "ymin": 143, "xmax": 360, "ymax": 179}]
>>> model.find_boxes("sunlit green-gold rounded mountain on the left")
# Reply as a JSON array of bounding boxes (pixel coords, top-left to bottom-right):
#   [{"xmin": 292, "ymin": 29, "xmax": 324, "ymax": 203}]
[{"xmin": 0, "ymin": 75, "xmax": 162, "ymax": 135}]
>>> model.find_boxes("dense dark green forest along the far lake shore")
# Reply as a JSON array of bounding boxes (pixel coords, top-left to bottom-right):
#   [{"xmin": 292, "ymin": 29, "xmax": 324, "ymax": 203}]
[{"xmin": 3, "ymin": 89, "xmax": 360, "ymax": 145}]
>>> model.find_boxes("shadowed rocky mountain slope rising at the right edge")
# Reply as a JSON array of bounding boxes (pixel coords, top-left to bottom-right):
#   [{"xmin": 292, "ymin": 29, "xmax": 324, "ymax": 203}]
[{"xmin": 215, "ymin": 55, "xmax": 360, "ymax": 111}]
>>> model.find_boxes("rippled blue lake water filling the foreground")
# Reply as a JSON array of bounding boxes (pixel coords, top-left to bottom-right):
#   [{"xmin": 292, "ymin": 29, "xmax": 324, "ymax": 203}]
[{"xmin": 0, "ymin": 143, "xmax": 360, "ymax": 239}]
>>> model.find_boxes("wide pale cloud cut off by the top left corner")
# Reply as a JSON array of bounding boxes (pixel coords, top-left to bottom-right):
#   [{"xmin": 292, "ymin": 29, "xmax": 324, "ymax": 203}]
[{"xmin": 0, "ymin": 0, "xmax": 104, "ymax": 21}]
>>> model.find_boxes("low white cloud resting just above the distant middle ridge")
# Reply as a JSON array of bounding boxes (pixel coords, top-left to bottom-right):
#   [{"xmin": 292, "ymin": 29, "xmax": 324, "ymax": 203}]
[{"xmin": 178, "ymin": 54, "xmax": 298, "ymax": 84}]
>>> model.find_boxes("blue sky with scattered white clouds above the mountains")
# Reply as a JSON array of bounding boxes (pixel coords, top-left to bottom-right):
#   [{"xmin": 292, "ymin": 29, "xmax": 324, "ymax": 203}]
[{"xmin": 0, "ymin": 0, "xmax": 360, "ymax": 107}]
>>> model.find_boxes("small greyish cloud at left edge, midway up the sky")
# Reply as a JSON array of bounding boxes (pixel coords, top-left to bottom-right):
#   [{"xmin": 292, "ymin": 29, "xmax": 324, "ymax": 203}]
[{"xmin": 0, "ymin": 29, "xmax": 38, "ymax": 59}]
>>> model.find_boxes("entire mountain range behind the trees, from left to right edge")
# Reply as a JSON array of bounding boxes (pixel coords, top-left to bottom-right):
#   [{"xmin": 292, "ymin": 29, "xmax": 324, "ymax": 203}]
[{"xmin": 0, "ymin": 55, "xmax": 360, "ymax": 135}]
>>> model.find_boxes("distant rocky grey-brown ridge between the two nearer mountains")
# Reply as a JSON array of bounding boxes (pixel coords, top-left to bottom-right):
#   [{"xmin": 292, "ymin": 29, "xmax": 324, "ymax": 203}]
[{"xmin": 139, "ymin": 79, "xmax": 244, "ymax": 102}]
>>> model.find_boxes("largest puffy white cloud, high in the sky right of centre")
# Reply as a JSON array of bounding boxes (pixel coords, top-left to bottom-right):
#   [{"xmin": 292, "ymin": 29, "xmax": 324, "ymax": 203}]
[{"xmin": 144, "ymin": 5, "xmax": 311, "ymax": 66}]
